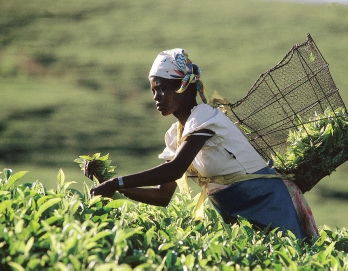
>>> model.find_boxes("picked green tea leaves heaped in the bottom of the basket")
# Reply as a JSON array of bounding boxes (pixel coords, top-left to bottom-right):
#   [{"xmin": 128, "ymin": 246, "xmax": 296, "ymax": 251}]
[{"xmin": 272, "ymin": 108, "xmax": 348, "ymax": 192}]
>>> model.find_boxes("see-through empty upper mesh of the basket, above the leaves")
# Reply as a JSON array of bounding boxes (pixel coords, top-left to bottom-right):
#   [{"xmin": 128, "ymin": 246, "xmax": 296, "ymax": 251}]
[{"xmin": 222, "ymin": 34, "xmax": 346, "ymax": 191}]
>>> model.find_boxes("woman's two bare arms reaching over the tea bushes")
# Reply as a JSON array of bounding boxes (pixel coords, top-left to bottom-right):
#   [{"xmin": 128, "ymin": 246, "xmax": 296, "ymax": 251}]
[{"xmin": 91, "ymin": 135, "xmax": 211, "ymax": 205}]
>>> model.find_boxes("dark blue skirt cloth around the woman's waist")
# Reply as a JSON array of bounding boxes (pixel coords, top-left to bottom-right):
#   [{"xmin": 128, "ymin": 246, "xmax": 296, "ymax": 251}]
[{"xmin": 209, "ymin": 167, "xmax": 305, "ymax": 238}]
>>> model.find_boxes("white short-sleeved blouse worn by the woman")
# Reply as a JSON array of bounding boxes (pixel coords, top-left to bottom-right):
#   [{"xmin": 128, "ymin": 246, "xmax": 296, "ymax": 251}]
[{"xmin": 158, "ymin": 104, "xmax": 267, "ymax": 181}]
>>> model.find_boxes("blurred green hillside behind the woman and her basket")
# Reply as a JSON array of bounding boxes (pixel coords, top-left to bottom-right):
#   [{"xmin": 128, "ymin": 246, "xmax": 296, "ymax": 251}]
[{"xmin": 0, "ymin": 0, "xmax": 348, "ymax": 230}]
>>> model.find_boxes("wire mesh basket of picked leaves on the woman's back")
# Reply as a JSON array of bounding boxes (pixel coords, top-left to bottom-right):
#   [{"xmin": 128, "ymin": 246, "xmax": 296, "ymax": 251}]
[{"xmin": 211, "ymin": 34, "xmax": 348, "ymax": 192}]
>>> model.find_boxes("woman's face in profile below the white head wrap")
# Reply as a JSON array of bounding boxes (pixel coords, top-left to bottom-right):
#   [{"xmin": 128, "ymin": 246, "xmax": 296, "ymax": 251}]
[{"xmin": 150, "ymin": 77, "xmax": 186, "ymax": 116}]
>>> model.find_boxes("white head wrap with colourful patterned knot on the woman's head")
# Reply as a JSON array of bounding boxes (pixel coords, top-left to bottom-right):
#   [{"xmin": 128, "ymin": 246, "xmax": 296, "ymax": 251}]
[{"xmin": 149, "ymin": 48, "xmax": 207, "ymax": 103}]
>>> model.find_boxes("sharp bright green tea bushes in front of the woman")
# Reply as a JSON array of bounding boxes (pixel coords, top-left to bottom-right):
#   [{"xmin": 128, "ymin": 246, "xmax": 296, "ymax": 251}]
[{"xmin": 0, "ymin": 169, "xmax": 348, "ymax": 270}]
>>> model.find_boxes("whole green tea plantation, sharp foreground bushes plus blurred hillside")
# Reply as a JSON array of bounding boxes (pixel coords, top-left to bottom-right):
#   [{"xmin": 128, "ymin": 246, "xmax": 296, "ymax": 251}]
[{"xmin": 0, "ymin": 0, "xmax": 348, "ymax": 270}]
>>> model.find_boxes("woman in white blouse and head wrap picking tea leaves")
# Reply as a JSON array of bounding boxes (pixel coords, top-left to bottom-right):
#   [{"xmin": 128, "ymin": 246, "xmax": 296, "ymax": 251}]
[{"xmin": 85, "ymin": 49, "xmax": 318, "ymax": 238}]
